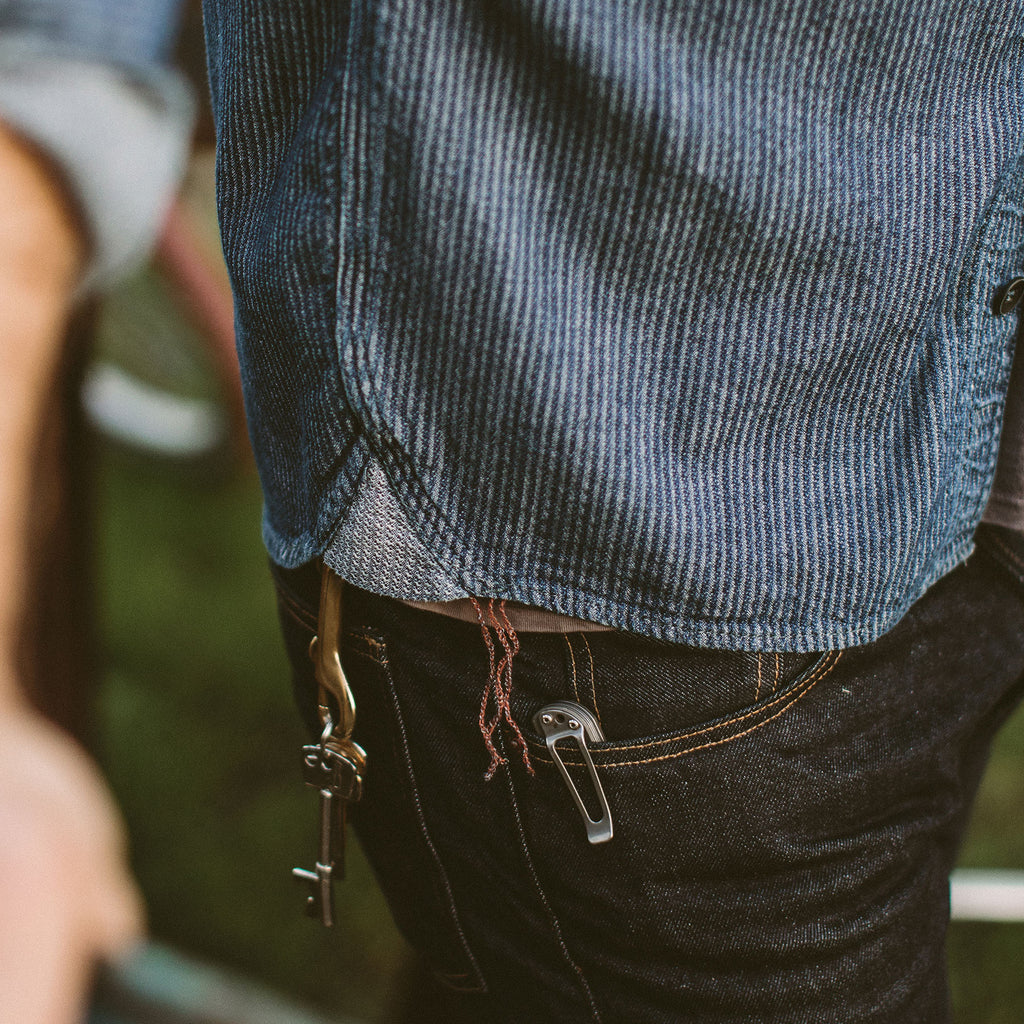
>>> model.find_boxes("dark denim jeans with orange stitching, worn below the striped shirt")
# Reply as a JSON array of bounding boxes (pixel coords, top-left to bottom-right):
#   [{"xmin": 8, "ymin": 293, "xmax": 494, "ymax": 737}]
[{"xmin": 276, "ymin": 527, "xmax": 1024, "ymax": 1024}]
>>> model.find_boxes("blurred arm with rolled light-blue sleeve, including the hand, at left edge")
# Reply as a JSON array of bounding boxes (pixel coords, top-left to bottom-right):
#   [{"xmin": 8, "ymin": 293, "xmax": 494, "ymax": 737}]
[{"xmin": 0, "ymin": 0, "xmax": 191, "ymax": 1024}]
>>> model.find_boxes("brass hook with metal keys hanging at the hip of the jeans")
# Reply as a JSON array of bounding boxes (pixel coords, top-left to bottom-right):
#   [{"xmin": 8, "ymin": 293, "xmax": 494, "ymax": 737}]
[{"xmin": 292, "ymin": 567, "xmax": 367, "ymax": 928}]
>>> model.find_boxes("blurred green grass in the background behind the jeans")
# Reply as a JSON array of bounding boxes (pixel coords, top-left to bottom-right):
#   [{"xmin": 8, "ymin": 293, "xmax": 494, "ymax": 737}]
[{"xmin": 90, "ymin": 249, "xmax": 1024, "ymax": 1024}]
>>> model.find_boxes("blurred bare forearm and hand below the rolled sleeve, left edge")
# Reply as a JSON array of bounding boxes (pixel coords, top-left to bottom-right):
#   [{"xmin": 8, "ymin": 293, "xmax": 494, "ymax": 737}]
[{"xmin": 0, "ymin": 119, "xmax": 141, "ymax": 1024}]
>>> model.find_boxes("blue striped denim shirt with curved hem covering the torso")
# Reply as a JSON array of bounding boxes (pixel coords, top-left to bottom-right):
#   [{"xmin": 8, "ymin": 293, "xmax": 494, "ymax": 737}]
[{"xmin": 206, "ymin": 0, "xmax": 1024, "ymax": 650}]
